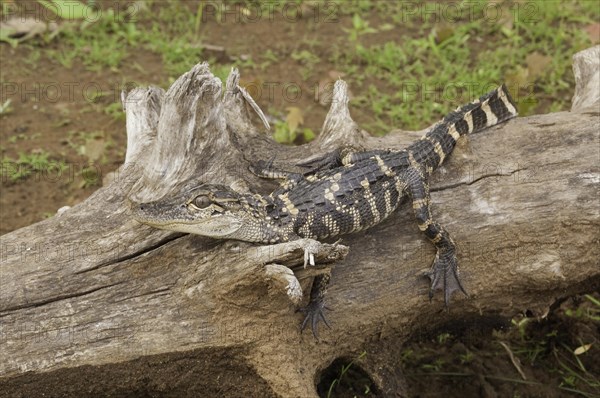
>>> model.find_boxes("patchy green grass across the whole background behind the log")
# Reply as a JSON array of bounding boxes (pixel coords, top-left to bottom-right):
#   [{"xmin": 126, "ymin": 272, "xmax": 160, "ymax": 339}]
[{"xmin": 0, "ymin": 0, "xmax": 600, "ymax": 179}]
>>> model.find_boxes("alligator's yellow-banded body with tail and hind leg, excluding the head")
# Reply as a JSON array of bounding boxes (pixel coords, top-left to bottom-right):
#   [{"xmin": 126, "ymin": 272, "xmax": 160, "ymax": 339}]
[{"xmin": 251, "ymin": 86, "xmax": 517, "ymax": 305}]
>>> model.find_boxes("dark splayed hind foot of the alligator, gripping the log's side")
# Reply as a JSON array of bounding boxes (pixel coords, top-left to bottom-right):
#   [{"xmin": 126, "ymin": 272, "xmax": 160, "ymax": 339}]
[{"xmin": 425, "ymin": 250, "xmax": 469, "ymax": 307}]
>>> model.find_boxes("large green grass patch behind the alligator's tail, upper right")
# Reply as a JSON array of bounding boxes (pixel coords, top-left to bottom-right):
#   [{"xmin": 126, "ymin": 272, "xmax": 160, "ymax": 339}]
[{"xmin": 324, "ymin": 1, "xmax": 598, "ymax": 133}]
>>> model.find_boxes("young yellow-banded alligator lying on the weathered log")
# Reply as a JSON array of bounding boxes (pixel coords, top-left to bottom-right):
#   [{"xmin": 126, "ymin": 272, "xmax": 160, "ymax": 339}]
[{"xmin": 134, "ymin": 86, "xmax": 517, "ymax": 336}]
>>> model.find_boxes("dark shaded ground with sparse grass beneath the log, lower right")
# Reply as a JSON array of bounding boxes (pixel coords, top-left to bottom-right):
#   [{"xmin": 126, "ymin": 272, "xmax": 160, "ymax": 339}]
[{"xmin": 400, "ymin": 294, "xmax": 600, "ymax": 397}]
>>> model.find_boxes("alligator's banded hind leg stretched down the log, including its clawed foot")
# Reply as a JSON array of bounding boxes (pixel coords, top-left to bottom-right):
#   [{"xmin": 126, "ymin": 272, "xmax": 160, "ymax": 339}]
[{"xmin": 406, "ymin": 168, "xmax": 468, "ymax": 306}]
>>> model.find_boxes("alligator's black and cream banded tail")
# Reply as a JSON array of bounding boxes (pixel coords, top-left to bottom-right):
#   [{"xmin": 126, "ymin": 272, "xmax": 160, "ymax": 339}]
[{"xmin": 407, "ymin": 84, "xmax": 517, "ymax": 171}]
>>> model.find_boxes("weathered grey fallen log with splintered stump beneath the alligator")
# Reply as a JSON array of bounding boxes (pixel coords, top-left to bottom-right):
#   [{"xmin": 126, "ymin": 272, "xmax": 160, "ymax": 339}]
[{"xmin": 0, "ymin": 47, "xmax": 600, "ymax": 397}]
